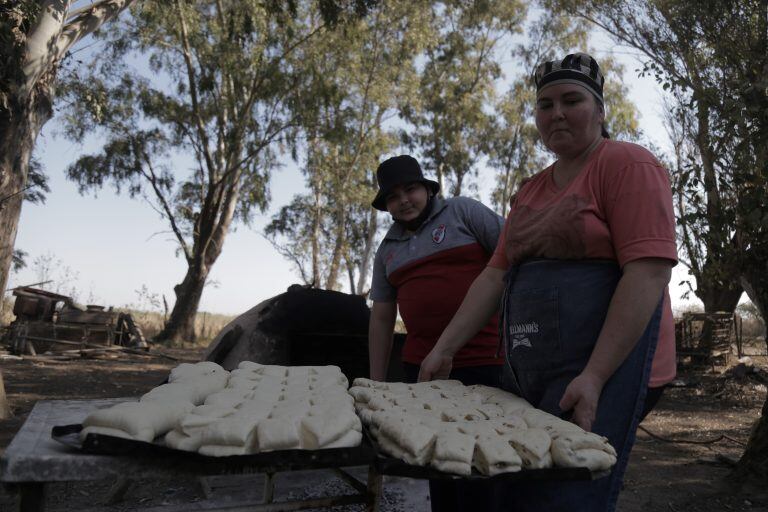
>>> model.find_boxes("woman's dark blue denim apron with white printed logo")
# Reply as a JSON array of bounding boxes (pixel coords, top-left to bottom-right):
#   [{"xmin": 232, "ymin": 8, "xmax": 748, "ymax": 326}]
[{"xmin": 501, "ymin": 260, "xmax": 661, "ymax": 512}]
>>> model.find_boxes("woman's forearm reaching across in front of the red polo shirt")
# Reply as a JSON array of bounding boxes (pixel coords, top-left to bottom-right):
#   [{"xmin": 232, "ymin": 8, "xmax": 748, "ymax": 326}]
[{"xmin": 419, "ymin": 267, "xmax": 505, "ymax": 381}]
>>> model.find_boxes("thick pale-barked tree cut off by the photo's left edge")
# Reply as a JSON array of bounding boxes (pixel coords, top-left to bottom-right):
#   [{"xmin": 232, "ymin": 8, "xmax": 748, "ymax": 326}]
[{"xmin": 0, "ymin": 0, "xmax": 133, "ymax": 308}]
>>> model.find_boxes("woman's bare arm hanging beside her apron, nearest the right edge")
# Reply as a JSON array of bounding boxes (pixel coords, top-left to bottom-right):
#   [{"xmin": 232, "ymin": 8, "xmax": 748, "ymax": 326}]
[{"xmin": 560, "ymin": 258, "xmax": 673, "ymax": 431}]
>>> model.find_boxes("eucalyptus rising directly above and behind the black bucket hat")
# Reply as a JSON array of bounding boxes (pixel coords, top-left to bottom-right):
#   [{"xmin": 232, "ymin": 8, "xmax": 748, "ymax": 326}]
[{"xmin": 402, "ymin": 0, "xmax": 528, "ymax": 195}]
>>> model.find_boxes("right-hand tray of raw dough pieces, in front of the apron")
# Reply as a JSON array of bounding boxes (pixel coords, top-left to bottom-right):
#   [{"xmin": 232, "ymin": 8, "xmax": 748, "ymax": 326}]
[{"xmin": 349, "ymin": 379, "xmax": 616, "ymax": 480}]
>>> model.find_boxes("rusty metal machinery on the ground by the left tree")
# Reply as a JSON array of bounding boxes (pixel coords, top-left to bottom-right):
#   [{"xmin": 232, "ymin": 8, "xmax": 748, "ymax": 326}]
[{"xmin": 3, "ymin": 287, "xmax": 148, "ymax": 355}]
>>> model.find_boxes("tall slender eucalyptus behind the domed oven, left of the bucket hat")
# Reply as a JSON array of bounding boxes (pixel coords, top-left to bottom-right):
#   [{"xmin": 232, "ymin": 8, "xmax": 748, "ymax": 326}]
[{"xmin": 266, "ymin": 0, "xmax": 431, "ymax": 294}]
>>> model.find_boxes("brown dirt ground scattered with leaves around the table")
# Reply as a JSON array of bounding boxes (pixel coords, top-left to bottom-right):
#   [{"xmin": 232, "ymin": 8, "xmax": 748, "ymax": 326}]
[{"xmin": 0, "ymin": 348, "xmax": 768, "ymax": 512}]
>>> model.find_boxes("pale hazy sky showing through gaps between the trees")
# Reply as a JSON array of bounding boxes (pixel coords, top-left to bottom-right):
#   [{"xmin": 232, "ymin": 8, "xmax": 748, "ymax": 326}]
[{"xmin": 8, "ymin": 18, "xmax": 712, "ymax": 315}]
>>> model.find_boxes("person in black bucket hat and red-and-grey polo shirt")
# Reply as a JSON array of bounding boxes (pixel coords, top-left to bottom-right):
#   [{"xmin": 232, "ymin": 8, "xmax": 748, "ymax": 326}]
[{"xmin": 368, "ymin": 155, "xmax": 502, "ymax": 511}]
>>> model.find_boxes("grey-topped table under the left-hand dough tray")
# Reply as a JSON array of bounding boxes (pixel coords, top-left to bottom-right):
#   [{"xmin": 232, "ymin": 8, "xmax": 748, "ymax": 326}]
[{"xmin": 0, "ymin": 398, "xmax": 382, "ymax": 512}]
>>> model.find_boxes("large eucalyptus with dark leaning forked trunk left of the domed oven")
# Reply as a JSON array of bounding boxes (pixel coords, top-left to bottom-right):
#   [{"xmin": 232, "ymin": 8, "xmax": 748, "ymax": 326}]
[{"xmin": 59, "ymin": 0, "xmax": 366, "ymax": 340}]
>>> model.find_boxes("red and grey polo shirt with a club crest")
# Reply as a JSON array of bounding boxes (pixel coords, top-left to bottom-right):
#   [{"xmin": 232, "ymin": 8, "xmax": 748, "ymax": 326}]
[{"xmin": 370, "ymin": 197, "xmax": 504, "ymax": 368}]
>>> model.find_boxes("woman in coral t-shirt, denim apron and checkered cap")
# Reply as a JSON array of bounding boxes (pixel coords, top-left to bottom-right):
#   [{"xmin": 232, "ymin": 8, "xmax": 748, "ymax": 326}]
[{"xmin": 420, "ymin": 53, "xmax": 677, "ymax": 512}]
